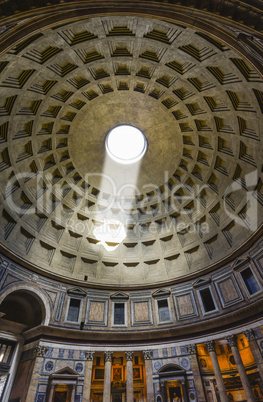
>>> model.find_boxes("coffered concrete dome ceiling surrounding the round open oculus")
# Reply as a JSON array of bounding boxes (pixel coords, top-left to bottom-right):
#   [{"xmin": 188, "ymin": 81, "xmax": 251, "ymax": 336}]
[{"xmin": 0, "ymin": 14, "xmax": 263, "ymax": 286}]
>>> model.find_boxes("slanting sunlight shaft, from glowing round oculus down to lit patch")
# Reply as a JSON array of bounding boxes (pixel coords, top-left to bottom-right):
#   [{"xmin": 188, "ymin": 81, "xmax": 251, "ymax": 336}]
[{"xmin": 93, "ymin": 125, "xmax": 147, "ymax": 251}]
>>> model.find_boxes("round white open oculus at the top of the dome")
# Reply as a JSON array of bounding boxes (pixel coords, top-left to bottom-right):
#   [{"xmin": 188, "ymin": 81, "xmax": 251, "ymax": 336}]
[{"xmin": 106, "ymin": 125, "xmax": 147, "ymax": 165}]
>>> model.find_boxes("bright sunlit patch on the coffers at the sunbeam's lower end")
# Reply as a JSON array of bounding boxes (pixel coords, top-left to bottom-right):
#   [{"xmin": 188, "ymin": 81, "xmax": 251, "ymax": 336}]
[{"xmin": 93, "ymin": 219, "xmax": 126, "ymax": 251}]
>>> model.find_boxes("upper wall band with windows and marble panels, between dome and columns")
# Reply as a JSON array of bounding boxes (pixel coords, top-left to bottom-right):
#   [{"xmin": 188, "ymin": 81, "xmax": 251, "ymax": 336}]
[{"xmin": 0, "ymin": 234, "xmax": 263, "ymax": 340}]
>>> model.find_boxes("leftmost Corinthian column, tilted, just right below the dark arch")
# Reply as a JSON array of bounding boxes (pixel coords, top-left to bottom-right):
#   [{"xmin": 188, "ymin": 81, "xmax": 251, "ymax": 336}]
[{"xmin": 25, "ymin": 345, "xmax": 48, "ymax": 402}]
